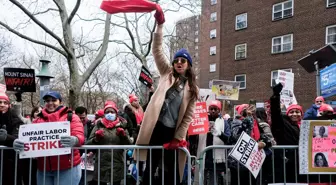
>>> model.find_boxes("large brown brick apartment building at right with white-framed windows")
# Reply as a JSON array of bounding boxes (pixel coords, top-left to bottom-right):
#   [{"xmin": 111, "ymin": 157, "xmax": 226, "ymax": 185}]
[{"xmin": 200, "ymin": 0, "xmax": 336, "ymax": 109}]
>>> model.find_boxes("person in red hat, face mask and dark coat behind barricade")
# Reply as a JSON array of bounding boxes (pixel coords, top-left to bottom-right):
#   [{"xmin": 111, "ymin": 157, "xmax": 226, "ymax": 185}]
[{"xmin": 86, "ymin": 101, "xmax": 132, "ymax": 185}]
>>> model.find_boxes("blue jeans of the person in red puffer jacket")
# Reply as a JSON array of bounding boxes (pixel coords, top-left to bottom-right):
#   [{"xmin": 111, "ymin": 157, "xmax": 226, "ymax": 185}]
[{"xmin": 37, "ymin": 165, "xmax": 82, "ymax": 185}]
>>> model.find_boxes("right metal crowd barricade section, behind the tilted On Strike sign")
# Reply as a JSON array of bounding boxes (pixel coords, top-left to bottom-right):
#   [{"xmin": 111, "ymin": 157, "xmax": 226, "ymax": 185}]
[{"xmin": 196, "ymin": 145, "xmax": 335, "ymax": 185}]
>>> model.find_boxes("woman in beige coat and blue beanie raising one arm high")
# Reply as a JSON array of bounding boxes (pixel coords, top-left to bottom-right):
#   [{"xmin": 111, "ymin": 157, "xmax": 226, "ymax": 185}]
[{"xmin": 134, "ymin": 5, "xmax": 198, "ymax": 185}]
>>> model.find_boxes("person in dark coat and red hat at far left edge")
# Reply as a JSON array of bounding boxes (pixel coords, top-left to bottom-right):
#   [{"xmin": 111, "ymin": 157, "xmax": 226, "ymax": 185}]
[{"xmin": 0, "ymin": 92, "xmax": 24, "ymax": 185}]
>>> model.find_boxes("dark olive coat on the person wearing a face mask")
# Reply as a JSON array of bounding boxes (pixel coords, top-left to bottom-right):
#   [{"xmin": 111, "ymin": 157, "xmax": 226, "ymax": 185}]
[{"xmin": 86, "ymin": 120, "xmax": 132, "ymax": 183}]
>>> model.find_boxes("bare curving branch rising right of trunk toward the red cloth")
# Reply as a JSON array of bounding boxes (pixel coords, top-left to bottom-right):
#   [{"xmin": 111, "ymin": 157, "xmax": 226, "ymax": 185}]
[{"xmin": 79, "ymin": 14, "xmax": 111, "ymax": 87}]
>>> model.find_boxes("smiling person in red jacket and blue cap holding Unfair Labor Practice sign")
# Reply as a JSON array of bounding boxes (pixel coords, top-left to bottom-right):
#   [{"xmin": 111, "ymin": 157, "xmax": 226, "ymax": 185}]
[{"xmin": 13, "ymin": 91, "xmax": 84, "ymax": 185}]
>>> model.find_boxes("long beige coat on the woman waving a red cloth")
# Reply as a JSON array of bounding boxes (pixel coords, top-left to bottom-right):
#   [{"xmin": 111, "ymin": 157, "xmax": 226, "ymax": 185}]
[{"xmin": 134, "ymin": 30, "xmax": 195, "ymax": 181}]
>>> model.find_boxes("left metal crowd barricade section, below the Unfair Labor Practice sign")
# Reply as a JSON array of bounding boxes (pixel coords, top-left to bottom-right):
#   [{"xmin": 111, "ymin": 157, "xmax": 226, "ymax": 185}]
[{"xmin": 0, "ymin": 145, "xmax": 191, "ymax": 185}]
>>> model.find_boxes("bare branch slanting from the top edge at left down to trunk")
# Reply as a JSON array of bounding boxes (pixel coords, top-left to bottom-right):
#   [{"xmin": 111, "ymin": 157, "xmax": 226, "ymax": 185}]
[{"xmin": 9, "ymin": 0, "xmax": 71, "ymax": 54}]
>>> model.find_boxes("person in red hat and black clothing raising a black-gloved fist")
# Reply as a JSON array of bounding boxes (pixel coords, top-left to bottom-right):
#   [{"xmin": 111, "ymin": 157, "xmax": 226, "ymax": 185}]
[{"xmin": 270, "ymin": 83, "xmax": 303, "ymax": 183}]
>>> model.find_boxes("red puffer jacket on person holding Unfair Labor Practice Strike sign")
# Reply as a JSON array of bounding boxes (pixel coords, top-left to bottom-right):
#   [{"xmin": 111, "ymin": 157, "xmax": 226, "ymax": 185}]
[{"xmin": 33, "ymin": 107, "xmax": 84, "ymax": 171}]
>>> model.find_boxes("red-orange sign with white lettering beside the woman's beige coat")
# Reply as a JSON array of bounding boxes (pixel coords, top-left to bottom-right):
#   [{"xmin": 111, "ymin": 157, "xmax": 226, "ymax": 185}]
[{"xmin": 188, "ymin": 102, "xmax": 209, "ymax": 135}]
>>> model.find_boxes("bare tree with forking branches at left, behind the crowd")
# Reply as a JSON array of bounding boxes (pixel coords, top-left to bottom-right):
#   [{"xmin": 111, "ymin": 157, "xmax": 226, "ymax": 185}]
[{"xmin": 0, "ymin": 0, "xmax": 111, "ymax": 107}]
